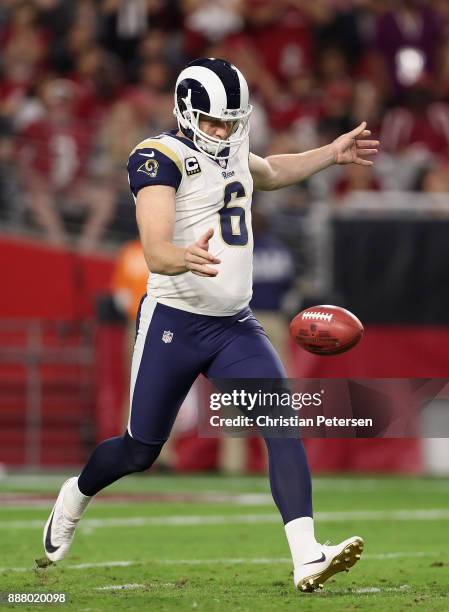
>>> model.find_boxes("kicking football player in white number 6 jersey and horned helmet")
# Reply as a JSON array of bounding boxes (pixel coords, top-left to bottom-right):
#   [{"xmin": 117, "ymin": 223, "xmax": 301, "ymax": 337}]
[{"xmin": 43, "ymin": 58, "xmax": 379, "ymax": 591}]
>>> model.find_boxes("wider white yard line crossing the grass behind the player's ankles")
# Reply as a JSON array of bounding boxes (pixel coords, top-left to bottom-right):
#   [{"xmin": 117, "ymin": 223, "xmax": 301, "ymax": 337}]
[{"xmin": 0, "ymin": 508, "xmax": 449, "ymax": 532}]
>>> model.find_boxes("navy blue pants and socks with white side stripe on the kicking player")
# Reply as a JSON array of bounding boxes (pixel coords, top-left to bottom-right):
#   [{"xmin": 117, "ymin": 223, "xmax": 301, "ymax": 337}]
[{"xmin": 78, "ymin": 296, "xmax": 312, "ymax": 523}]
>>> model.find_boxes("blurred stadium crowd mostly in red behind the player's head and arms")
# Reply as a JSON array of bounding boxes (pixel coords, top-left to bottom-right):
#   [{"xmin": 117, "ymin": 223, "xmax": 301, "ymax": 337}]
[{"xmin": 0, "ymin": 0, "xmax": 449, "ymax": 250}]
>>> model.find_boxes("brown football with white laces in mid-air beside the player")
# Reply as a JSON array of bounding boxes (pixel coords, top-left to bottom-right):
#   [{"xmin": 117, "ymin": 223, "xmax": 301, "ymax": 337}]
[{"xmin": 290, "ymin": 305, "xmax": 363, "ymax": 355}]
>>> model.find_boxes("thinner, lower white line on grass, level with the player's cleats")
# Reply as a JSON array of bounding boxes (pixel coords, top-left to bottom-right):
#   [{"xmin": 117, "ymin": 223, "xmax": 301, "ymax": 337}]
[{"xmin": 0, "ymin": 551, "xmax": 438, "ymax": 572}]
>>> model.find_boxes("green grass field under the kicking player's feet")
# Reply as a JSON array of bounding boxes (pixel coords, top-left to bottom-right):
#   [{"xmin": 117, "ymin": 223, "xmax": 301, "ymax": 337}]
[{"xmin": 0, "ymin": 474, "xmax": 449, "ymax": 612}]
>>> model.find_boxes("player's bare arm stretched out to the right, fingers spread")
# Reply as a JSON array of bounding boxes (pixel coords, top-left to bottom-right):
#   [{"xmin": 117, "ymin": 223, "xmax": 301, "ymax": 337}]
[{"xmin": 249, "ymin": 121, "xmax": 380, "ymax": 191}]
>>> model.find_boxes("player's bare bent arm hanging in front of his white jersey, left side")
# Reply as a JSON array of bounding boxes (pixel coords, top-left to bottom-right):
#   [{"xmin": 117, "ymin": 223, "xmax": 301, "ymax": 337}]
[{"xmin": 136, "ymin": 185, "xmax": 220, "ymax": 276}]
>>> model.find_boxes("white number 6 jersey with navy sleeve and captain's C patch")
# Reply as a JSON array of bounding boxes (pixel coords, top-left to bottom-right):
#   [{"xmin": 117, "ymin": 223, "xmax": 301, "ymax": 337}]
[{"xmin": 128, "ymin": 132, "xmax": 253, "ymax": 316}]
